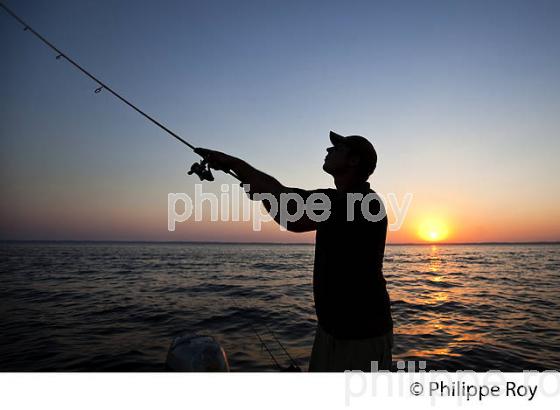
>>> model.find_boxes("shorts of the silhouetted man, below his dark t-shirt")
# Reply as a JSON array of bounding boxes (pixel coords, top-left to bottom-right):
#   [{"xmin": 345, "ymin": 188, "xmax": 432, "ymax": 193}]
[{"xmin": 309, "ymin": 325, "xmax": 393, "ymax": 372}]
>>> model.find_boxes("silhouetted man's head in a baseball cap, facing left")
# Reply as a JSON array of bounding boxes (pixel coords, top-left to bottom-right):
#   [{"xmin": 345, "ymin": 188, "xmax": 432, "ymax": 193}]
[{"xmin": 323, "ymin": 131, "xmax": 377, "ymax": 181}]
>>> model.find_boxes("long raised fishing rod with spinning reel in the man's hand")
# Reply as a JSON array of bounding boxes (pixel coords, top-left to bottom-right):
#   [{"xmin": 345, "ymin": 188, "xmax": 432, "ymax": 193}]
[{"xmin": 0, "ymin": 2, "xmax": 239, "ymax": 181}]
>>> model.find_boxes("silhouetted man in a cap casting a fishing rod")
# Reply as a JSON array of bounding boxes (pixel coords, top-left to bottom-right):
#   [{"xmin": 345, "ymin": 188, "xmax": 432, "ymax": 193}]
[{"xmin": 196, "ymin": 132, "xmax": 393, "ymax": 372}]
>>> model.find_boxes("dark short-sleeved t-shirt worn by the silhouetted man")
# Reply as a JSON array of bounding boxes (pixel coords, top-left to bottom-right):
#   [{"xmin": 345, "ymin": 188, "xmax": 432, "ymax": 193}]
[{"xmin": 298, "ymin": 183, "xmax": 393, "ymax": 339}]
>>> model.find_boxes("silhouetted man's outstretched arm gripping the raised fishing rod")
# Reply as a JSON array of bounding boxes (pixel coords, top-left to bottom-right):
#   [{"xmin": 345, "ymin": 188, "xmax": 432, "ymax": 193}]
[{"xmin": 195, "ymin": 148, "xmax": 317, "ymax": 232}]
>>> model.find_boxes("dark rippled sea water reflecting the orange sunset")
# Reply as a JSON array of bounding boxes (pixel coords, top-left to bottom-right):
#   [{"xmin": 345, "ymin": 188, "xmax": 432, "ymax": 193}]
[{"xmin": 0, "ymin": 242, "xmax": 560, "ymax": 371}]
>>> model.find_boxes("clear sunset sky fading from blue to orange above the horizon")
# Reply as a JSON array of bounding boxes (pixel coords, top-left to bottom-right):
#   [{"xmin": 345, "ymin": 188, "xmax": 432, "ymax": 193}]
[{"xmin": 0, "ymin": 0, "xmax": 560, "ymax": 243}]
